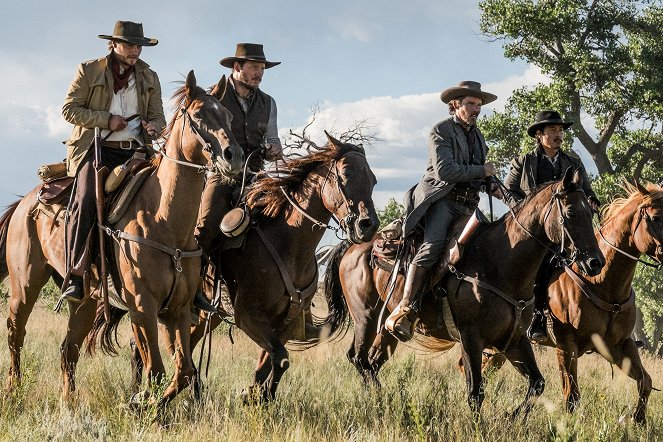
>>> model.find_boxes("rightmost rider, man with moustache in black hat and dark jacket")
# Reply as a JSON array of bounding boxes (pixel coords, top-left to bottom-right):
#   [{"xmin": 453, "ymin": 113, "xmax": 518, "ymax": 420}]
[{"xmin": 504, "ymin": 110, "xmax": 601, "ymax": 343}]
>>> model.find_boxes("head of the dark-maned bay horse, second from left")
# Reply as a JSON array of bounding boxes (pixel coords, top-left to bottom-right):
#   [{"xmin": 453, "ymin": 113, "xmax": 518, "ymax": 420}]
[{"xmin": 323, "ymin": 132, "xmax": 380, "ymax": 244}]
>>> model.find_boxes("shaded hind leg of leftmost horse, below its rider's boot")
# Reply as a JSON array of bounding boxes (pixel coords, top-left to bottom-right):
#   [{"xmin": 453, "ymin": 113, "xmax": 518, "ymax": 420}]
[{"xmin": 60, "ymin": 297, "xmax": 98, "ymax": 400}]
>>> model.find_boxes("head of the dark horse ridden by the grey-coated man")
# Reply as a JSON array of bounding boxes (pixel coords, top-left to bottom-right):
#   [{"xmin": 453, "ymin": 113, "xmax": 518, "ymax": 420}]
[{"xmin": 544, "ymin": 167, "xmax": 605, "ymax": 276}]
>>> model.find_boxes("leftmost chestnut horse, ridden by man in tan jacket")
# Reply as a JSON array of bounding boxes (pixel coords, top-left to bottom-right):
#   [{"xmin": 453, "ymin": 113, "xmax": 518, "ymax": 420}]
[{"xmin": 0, "ymin": 71, "xmax": 243, "ymax": 404}]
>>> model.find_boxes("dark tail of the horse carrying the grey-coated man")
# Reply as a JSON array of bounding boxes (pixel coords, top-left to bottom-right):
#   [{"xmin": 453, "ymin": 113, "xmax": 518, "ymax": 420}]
[{"xmin": 323, "ymin": 240, "xmax": 352, "ymax": 340}]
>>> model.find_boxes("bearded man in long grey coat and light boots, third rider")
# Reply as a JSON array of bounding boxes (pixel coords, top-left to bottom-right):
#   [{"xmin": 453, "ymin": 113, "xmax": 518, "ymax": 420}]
[{"xmin": 385, "ymin": 81, "xmax": 497, "ymax": 341}]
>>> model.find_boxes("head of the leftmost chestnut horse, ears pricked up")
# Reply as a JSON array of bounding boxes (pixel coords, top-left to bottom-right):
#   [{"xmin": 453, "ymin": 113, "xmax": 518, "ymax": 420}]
[{"xmin": 178, "ymin": 71, "xmax": 244, "ymax": 177}]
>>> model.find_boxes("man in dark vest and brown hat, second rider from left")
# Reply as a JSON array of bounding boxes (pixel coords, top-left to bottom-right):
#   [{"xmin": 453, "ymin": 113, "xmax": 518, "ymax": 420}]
[{"xmin": 195, "ymin": 43, "xmax": 281, "ymax": 255}]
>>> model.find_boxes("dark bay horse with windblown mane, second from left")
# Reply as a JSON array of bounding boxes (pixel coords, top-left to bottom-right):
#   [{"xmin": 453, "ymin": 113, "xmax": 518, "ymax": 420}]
[{"xmin": 134, "ymin": 134, "xmax": 379, "ymax": 402}]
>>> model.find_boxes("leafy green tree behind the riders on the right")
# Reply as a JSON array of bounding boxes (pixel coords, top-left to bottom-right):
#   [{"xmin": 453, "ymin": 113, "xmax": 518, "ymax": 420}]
[{"xmin": 480, "ymin": 0, "xmax": 663, "ymax": 350}]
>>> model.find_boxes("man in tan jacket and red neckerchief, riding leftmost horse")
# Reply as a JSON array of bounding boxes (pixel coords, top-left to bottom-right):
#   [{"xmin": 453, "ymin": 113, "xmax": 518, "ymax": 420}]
[{"xmin": 62, "ymin": 21, "xmax": 166, "ymax": 302}]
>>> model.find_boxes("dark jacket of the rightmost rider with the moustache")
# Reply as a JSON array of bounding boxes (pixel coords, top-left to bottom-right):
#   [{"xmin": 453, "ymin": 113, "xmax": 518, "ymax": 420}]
[{"xmin": 504, "ymin": 148, "xmax": 600, "ymax": 206}]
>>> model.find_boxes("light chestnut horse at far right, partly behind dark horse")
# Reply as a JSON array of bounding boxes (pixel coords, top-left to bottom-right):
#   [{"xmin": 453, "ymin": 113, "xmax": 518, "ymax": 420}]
[{"xmin": 487, "ymin": 181, "xmax": 663, "ymax": 423}]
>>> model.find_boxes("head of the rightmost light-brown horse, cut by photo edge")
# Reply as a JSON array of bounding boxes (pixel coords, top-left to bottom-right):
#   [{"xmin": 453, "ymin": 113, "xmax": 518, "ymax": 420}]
[{"xmin": 631, "ymin": 179, "xmax": 663, "ymax": 263}]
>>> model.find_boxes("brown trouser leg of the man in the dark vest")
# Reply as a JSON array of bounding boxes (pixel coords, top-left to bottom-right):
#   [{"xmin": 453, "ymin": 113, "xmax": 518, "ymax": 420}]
[{"xmin": 195, "ymin": 175, "xmax": 237, "ymax": 256}]
